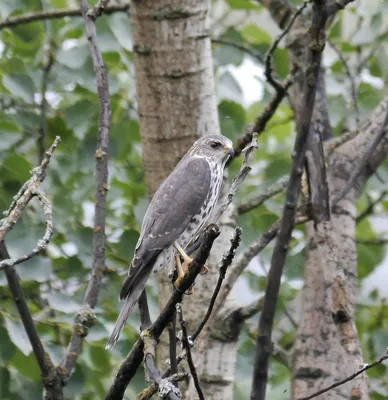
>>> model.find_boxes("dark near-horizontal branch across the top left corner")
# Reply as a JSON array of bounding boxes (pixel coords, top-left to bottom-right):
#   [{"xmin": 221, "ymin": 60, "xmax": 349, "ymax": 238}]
[{"xmin": 0, "ymin": 4, "xmax": 129, "ymax": 30}]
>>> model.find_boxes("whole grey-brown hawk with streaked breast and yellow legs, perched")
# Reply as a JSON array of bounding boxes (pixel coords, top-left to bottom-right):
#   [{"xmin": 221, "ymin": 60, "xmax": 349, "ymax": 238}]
[{"xmin": 106, "ymin": 135, "xmax": 233, "ymax": 349}]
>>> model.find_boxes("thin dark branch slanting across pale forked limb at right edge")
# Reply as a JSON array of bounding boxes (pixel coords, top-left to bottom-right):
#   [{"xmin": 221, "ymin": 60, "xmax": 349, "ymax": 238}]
[{"xmin": 332, "ymin": 111, "xmax": 388, "ymax": 208}]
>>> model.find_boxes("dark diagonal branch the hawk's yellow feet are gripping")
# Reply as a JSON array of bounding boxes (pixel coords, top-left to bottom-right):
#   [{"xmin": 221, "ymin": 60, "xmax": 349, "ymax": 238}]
[{"xmin": 105, "ymin": 225, "xmax": 220, "ymax": 400}]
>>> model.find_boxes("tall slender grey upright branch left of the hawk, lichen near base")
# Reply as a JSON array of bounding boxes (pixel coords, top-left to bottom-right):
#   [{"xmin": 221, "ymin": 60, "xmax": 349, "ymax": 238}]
[{"xmin": 61, "ymin": 0, "xmax": 110, "ymax": 378}]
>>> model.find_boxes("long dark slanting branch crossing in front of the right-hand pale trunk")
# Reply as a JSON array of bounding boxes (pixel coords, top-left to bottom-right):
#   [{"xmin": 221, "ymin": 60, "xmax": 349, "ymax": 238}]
[{"xmin": 251, "ymin": 0, "xmax": 327, "ymax": 400}]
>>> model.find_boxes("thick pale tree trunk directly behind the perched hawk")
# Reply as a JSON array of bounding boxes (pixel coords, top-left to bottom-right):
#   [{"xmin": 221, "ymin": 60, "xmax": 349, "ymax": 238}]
[{"xmin": 130, "ymin": 0, "xmax": 236, "ymax": 400}]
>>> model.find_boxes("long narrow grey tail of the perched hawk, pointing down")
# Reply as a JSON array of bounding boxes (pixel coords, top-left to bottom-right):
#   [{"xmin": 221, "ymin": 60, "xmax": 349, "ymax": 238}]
[{"xmin": 105, "ymin": 266, "xmax": 152, "ymax": 350}]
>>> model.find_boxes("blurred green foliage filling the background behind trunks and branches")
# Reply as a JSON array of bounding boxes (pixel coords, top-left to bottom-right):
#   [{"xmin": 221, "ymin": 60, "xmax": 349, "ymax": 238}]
[{"xmin": 0, "ymin": 0, "xmax": 388, "ymax": 400}]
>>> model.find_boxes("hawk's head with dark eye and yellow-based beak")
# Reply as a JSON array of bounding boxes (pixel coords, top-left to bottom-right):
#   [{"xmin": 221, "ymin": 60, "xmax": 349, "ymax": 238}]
[{"xmin": 189, "ymin": 135, "xmax": 234, "ymax": 165}]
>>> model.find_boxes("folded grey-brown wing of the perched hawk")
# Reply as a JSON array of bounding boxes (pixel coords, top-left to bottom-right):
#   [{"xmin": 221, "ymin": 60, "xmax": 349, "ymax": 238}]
[{"xmin": 120, "ymin": 157, "xmax": 211, "ymax": 299}]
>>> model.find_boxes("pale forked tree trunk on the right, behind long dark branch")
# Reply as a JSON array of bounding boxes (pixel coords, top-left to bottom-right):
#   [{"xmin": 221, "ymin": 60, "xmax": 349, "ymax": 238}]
[{"xmin": 263, "ymin": 0, "xmax": 387, "ymax": 399}]
